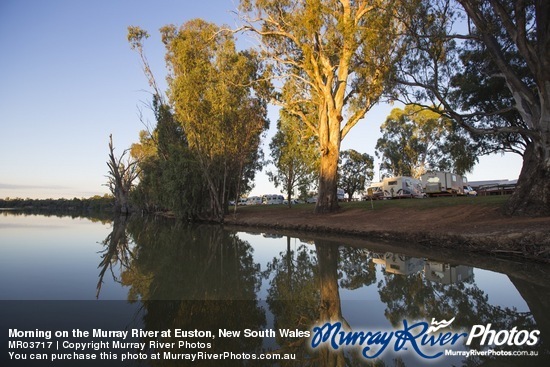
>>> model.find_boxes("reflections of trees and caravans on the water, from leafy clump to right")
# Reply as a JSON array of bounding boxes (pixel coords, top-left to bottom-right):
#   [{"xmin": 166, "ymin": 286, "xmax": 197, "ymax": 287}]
[{"xmin": 89, "ymin": 220, "xmax": 550, "ymax": 366}]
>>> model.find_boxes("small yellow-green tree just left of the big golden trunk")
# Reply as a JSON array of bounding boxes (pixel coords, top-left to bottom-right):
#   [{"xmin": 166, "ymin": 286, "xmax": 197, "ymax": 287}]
[{"xmin": 267, "ymin": 109, "xmax": 319, "ymax": 207}]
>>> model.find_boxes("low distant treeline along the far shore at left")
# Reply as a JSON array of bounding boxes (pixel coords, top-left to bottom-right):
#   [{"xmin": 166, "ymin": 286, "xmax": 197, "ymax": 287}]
[{"xmin": 0, "ymin": 195, "xmax": 114, "ymax": 212}]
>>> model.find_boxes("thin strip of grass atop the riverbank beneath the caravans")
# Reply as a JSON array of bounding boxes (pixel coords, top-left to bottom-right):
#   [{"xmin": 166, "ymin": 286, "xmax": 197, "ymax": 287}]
[{"xmin": 235, "ymin": 195, "xmax": 510, "ymax": 213}]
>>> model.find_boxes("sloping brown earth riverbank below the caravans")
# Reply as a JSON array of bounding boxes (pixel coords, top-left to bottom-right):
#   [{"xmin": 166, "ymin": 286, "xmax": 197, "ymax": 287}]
[{"xmin": 225, "ymin": 197, "xmax": 550, "ymax": 263}]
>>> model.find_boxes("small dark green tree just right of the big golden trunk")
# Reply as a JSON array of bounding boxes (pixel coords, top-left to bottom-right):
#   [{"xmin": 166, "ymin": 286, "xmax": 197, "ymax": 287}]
[{"xmin": 338, "ymin": 149, "xmax": 374, "ymax": 200}]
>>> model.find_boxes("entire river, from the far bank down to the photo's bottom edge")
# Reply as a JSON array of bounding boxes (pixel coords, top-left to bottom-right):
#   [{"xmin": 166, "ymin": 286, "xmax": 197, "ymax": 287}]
[{"xmin": 0, "ymin": 211, "xmax": 550, "ymax": 367}]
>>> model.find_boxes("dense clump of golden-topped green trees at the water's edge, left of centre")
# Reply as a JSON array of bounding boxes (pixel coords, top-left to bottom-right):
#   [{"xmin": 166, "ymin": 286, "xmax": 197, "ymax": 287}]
[{"xmin": 128, "ymin": 19, "xmax": 270, "ymax": 221}]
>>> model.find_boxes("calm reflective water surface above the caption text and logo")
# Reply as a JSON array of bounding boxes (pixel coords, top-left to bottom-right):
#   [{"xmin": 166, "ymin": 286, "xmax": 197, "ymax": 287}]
[{"xmin": 0, "ymin": 212, "xmax": 550, "ymax": 366}]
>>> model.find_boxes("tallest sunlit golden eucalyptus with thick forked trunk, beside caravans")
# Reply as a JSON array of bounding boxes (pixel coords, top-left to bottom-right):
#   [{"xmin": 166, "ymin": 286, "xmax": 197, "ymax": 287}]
[{"xmin": 240, "ymin": 0, "xmax": 401, "ymax": 213}]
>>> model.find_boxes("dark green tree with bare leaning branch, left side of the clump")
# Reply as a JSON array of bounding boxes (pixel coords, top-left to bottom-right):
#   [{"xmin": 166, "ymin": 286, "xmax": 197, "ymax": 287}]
[{"xmin": 128, "ymin": 26, "xmax": 209, "ymax": 220}]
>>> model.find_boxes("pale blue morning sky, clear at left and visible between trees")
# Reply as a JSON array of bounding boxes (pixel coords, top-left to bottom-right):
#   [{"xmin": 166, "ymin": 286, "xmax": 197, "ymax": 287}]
[{"xmin": 0, "ymin": 0, "xmax": 521, "ymax": 198}]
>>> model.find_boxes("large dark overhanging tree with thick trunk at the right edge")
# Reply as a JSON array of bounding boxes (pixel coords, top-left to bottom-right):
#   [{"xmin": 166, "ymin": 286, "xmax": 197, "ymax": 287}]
[{"xmin": 396, "ymin": 0, "xmax": 550, "ymax": 215}]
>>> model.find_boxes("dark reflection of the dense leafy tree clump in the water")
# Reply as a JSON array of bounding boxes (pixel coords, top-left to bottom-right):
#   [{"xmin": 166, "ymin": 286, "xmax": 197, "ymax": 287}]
[{"xmin": 98, "ymin": 219, "xmax": 266, "ymax": 366}]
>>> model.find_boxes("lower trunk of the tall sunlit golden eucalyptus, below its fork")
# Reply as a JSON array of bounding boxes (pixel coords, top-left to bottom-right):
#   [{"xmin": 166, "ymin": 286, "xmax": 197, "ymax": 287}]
[{"xmin": 315, "ymin": 136, "xmax": 340, "ymax": 214}]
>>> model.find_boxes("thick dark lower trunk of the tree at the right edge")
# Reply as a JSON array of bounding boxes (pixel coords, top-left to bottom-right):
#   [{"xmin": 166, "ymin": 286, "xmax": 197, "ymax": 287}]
[{"xmin": 504, "ymin": 143, "xmax": 550, "ymax": 216}]
